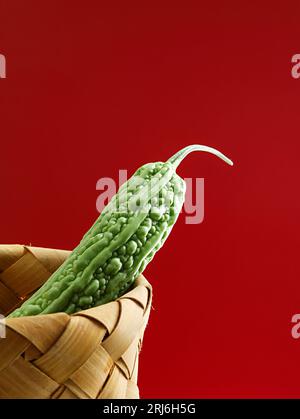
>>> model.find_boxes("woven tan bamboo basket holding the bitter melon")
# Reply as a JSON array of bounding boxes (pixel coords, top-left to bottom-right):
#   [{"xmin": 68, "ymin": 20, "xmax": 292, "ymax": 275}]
[{"xmin": 0, "ymin": 245, "xmax": 152, "ymax": 399}]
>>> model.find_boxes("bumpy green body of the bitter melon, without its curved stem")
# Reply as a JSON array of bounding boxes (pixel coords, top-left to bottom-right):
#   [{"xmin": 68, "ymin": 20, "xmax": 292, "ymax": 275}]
[{"xmin": 10, "ymin": 162, "xmax": 185, "ymax": 317}]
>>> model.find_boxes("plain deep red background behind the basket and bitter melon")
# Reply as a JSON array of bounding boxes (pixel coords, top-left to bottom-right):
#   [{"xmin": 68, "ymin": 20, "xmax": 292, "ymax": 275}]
[{"xmin": 0, "ymin": 0, "xmax": 300, "ymax": 397}]
